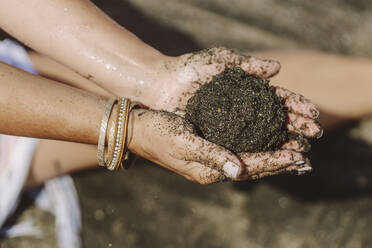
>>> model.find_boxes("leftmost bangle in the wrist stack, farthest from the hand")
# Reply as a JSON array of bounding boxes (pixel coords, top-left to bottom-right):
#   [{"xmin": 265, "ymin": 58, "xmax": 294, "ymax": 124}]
[{"xmin": 97, "ymin": 99, "xmax": 117, "ymax": 166}]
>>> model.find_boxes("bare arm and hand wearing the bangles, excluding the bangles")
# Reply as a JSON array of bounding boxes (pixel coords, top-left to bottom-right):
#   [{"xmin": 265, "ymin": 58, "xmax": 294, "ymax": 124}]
[{"xmin": 0, "ymin": 63, "xmax": 310, "ymax": 184}]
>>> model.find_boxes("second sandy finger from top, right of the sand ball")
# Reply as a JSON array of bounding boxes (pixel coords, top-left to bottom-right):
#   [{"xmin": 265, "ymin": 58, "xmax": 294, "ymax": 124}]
[{"xmin": 287, "ymin": 113, "xmax": 323, "ymax": 138}]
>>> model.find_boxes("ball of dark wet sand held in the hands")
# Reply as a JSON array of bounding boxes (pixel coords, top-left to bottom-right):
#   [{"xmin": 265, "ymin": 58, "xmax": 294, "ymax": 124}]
[{"xmin": 185, "ymin": 67, "xmax": 288, "ymax": 153}]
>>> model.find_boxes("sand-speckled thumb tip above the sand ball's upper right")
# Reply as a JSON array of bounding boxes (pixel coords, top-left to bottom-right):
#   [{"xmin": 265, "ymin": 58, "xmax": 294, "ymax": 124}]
[{"xmin": 239, "ymin": 56, "xmax": 280, "ymax": 78}]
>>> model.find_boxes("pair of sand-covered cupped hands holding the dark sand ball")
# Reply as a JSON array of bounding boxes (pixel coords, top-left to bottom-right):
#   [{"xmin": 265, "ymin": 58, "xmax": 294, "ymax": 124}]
[{"xmin": 120, "ymin": 48, "xmax": 322, "ymax": 184}]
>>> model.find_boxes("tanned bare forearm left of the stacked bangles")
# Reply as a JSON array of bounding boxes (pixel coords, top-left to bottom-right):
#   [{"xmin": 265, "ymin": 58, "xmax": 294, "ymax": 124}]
[{"xmin": 0, "ymin": 63, "xmax": 105, "ymax": 144}]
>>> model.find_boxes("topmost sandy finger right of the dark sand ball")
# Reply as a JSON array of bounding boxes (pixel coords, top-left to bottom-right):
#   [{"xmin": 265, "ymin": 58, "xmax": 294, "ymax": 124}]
[{"xmin": 275, "ymin": 87, "xmax": 319, "ymax": 119}]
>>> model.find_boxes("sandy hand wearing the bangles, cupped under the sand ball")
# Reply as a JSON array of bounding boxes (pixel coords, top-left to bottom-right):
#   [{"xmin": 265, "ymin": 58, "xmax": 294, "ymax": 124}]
[{"xmin": 128, "ymin": 109, "xmax": 311, "ymax": 184}]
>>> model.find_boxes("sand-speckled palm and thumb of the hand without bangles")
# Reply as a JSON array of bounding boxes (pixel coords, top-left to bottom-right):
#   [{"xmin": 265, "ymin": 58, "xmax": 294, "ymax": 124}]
[{"xmin": 154, "ymin": 48, "xmax": 280, "ymax": 114}]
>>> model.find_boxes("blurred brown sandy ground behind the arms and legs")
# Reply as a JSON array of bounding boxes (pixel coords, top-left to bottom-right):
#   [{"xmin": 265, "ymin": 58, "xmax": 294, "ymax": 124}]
[{"xmin": 0, "ymin": 0, "xmax": 372, "ymax": 248}]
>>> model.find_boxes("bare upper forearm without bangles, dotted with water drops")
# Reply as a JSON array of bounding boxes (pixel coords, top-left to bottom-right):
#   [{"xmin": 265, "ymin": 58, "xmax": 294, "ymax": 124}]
[{"xmin": 0, "ymin": 0, "xmax": 162, "ymax": 97}]
